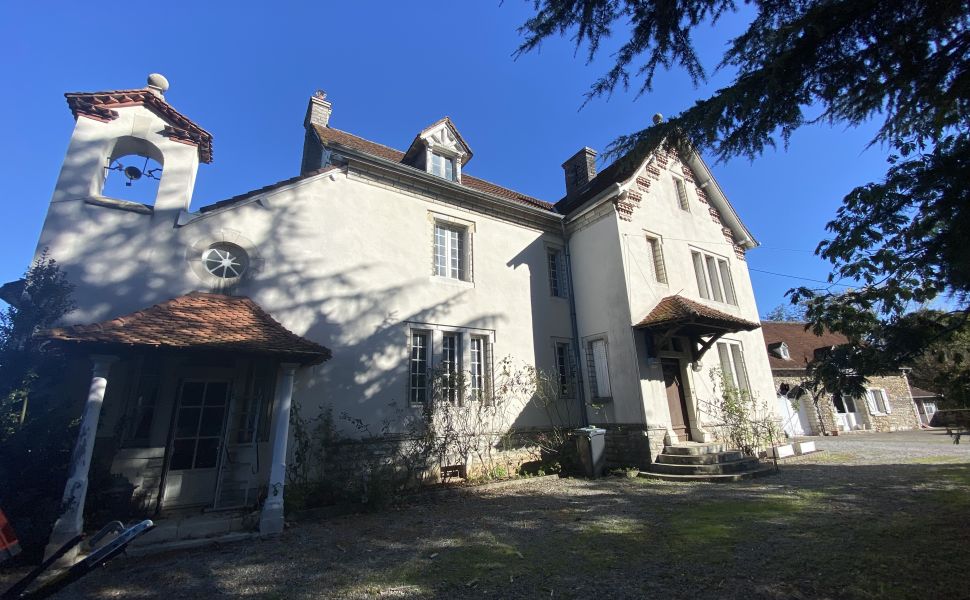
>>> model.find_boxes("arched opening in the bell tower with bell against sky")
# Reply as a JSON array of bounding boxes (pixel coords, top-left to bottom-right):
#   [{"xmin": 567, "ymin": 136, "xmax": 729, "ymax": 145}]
[{"xmin": 100, "ymin": 136, "xmax": 165, "ymax": 206}]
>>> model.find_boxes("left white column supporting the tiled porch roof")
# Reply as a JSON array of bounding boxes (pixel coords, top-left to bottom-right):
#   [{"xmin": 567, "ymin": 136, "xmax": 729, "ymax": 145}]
[{"xmin": 44, "ymin": 356, "xmax": 118, "ymax": 564}]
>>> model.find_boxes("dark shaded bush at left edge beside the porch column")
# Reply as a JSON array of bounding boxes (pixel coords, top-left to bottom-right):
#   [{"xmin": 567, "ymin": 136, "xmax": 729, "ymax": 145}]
[{"xmin": 0, "ymin": 255, "xmax": 78, "ymax": 560}]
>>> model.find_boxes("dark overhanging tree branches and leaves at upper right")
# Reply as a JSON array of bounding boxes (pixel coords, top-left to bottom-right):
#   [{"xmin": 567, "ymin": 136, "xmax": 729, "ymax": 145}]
[{"xmin": 519, "ymin": 0, "xmax": 970, "ymax": 375}]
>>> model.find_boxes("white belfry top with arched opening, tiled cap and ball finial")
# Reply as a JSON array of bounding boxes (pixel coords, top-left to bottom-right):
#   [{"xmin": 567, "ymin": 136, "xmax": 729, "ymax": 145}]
[{"xmin": 51, "ymin": 73, "xmax": 212, "ymax": 219}]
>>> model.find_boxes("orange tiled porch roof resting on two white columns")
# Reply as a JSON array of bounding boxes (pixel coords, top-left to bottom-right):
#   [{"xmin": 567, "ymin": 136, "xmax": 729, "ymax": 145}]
[{"xmin": 38, "ymin": 292, "xmax": 330, "ymax": 363}]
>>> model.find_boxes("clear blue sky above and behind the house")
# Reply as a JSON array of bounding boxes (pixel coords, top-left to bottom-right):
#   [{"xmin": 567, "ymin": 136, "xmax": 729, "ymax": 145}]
[{"xmin": 0, "ymin": 0, "xmax": 885, "ymax": 314}]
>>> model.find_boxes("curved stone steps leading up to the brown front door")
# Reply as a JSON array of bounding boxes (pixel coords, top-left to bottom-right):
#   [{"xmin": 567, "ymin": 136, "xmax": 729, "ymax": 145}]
[{"xmin": 640, "ymin": 442, "xmax": 774, "ymax": 482}]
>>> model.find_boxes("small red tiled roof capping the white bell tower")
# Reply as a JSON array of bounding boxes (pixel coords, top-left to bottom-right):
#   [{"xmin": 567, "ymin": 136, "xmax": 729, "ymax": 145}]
[{"xmin": 64, "ymin": 89, "xmax": 212, "ymax": 163}]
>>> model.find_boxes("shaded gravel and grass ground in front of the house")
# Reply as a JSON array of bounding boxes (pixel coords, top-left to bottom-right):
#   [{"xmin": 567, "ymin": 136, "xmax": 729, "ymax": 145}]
[{"xmin": 9, "ymin": 431, "xmax": 970, "ymax": 598}]
